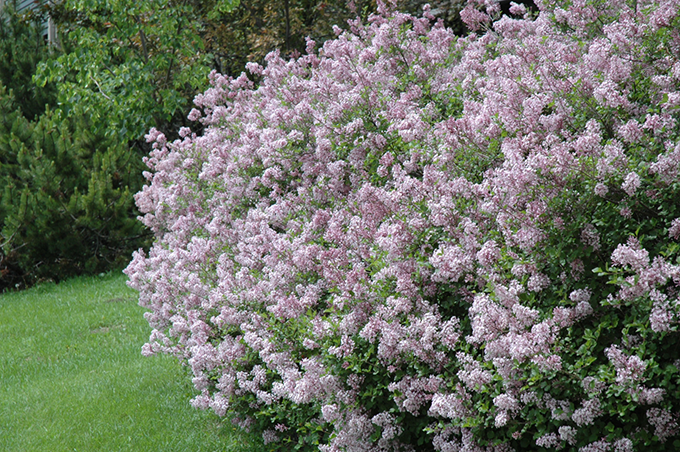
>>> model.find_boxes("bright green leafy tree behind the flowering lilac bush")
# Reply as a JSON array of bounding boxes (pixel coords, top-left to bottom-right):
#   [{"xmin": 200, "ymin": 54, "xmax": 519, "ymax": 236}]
[{"xmin": 37, "ymin": 0, "xmax": 235, "ymax": 142}]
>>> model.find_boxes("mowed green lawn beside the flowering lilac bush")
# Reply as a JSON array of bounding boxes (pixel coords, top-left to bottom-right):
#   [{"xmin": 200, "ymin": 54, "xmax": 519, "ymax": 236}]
[{"xmin": 0, "ymin": 274, "xmax": 255, "ymax": 452}]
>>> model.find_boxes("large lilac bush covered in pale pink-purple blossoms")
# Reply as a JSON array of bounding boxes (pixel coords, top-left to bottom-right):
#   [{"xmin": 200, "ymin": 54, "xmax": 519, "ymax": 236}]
[{"xmin": 126, "ymin": 0, "xmax": 680, "ymax": 452}]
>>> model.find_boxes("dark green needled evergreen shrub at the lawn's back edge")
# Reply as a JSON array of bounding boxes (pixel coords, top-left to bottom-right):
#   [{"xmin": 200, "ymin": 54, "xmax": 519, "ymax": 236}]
[{"xmin": 0, "ymin": 4, "xmax": 148, "ymax": 290}]
